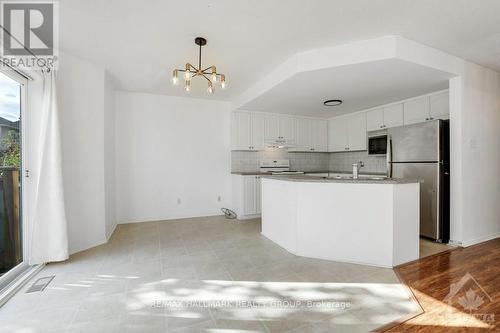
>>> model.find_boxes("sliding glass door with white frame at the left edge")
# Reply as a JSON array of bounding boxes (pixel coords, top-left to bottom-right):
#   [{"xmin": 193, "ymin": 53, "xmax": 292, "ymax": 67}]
[{"xmin": 0, "ymin": 71, "xmax": 28, "ymax": 290}]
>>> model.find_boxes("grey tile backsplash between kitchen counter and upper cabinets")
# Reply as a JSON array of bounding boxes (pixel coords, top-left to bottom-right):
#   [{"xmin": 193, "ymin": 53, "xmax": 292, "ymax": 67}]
[{"xmin": 231, "ymin": 148, "xmax": 387, "ymax": 173}]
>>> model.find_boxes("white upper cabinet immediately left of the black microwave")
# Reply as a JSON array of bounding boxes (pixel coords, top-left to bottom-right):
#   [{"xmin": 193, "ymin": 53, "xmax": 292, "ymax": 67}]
[{"xmin": 328, "ymin": 112, "xmax": 366, "ymax": 152}]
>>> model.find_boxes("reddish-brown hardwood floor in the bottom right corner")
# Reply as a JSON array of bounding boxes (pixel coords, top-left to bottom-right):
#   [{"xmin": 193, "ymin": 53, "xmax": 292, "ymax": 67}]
[{"xmin": 386, "ymin": 238, "xmax": 500, "ymax": 333}]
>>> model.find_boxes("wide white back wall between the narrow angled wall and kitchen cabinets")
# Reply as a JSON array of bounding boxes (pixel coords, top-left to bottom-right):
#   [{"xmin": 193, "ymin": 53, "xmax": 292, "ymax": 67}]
[{"xmin": 115, "ymin": 92, "xmax": 231, "ymax": 223}]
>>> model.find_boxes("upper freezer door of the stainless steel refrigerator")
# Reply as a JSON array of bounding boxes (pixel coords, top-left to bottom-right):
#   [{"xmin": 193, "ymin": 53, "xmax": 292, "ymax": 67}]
[{"xmin": 388, "ymin": 120, "xmax": 441, "ymax": 162}]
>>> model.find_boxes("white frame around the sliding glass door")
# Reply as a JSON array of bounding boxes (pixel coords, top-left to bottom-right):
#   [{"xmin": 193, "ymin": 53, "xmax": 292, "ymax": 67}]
[{"xmin": 0, "ymin": 69, "xmax": 30, "ymax": 294}]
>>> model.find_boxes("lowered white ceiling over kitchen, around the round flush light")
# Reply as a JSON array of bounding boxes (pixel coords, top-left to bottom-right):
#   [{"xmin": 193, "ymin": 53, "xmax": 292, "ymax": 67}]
[{"xmin": 241, "ymin": 59, "xmax": 452, "ymax": 118}]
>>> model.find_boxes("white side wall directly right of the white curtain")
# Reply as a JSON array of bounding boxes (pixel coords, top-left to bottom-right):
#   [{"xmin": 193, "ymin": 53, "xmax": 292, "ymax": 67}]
[{"xmin": 57, "ymin": 54, "xmax": 106, "ymax": 253}]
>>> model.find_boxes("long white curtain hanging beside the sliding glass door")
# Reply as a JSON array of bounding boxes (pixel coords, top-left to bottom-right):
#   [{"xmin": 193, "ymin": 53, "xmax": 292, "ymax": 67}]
[{"xmin": 28, "ymin": 70, "xmax": 68, "ymax": 265}]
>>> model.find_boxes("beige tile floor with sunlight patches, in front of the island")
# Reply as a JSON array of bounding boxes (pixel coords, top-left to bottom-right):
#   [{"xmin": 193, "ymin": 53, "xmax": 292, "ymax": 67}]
[{"xmin": 0, "ymin": 217, "xmax": 418, "ymax": 333}]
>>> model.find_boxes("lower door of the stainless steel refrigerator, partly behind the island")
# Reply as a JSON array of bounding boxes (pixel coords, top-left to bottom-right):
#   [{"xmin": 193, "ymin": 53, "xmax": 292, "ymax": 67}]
[{"xmin": 392, "ymin": 163, "xmax": 441, "ymax": 240}]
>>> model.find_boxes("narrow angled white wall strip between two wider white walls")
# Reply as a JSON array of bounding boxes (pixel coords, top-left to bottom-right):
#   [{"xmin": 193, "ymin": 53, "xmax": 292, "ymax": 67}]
[{"xmin": 104, "ymin": 73, "xmax": 116, "ymax": 239}]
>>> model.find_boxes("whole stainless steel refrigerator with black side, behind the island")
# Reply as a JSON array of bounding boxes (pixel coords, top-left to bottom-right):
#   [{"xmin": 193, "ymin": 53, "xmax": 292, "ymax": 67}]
[{"xmin": 387, "ymin": 120, "xmax": 450, "ymax": 242}]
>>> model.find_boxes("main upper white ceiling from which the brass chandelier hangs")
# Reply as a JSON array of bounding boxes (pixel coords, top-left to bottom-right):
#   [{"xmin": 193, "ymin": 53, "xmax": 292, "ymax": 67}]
[{"xmin": 60, "ymin": 0, "xmax": 500, "ymax": 101}]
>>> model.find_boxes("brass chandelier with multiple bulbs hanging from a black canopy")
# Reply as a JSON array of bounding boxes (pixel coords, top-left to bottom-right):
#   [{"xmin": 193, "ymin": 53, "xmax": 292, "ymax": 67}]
[{"xmin": 172, "ymin": 37, "xmax": 226, "ymax": 94}]
